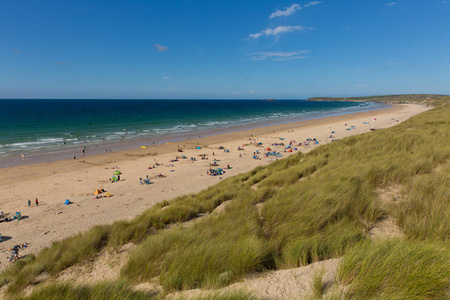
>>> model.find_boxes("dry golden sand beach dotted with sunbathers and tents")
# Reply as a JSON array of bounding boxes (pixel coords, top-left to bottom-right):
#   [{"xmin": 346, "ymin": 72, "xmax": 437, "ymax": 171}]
[{"xmin": 0, "ymin": 104, "xmax": 430, "ymax": 269}]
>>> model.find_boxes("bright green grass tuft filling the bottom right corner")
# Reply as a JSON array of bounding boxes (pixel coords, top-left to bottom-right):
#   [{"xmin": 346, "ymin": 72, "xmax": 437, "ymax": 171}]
[{"xmin": 339, "ymin": 240, "xmax": 450, "ymax": 299}]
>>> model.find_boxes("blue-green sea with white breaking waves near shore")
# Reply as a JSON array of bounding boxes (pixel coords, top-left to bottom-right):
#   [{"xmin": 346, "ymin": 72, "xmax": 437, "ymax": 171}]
[{"xmin": 0, "ymin": 100, "xmax": 386, "ymax": 158}]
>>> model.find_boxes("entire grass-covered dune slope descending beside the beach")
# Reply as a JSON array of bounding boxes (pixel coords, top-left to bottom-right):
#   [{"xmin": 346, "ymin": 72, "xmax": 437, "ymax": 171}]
[{"xmin": 0, "ymin": 100, "xmax": 450, "ymax": 299}]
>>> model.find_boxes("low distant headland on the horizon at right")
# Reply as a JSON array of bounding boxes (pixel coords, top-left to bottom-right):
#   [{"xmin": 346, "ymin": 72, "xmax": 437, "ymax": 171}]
[{"xmin": 307, "ymin": 94, "xmax": 450, "ymax": 105}]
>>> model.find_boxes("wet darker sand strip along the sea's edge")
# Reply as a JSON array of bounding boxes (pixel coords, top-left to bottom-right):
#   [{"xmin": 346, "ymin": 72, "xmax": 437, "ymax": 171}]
[{"xmin": 0, "ymin": 102, "xmax": 390, "ymax": 169}]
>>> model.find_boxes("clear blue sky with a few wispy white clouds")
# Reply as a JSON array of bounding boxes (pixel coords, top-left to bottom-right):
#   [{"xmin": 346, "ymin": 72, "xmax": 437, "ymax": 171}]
[{"xmin": 0, "ymin": 0, "xmax": 450, "ymax": 99}]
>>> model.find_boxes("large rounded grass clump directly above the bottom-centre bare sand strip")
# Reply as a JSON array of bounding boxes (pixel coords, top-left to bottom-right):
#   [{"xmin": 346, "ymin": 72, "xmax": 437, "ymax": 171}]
[{"xmin": 121, "ymin": 192, "xmax": 270, "ymax": 291}]
